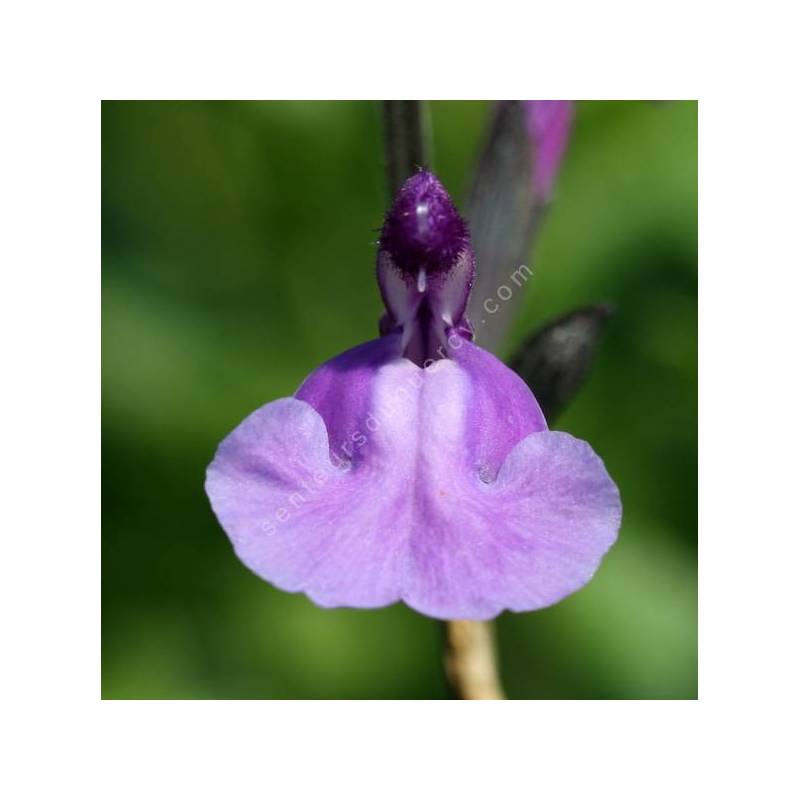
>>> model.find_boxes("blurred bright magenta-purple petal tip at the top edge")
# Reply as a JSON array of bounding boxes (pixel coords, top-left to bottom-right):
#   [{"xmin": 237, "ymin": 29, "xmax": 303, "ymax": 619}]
[{"xmin": 524, "ymin": 100, "xmax": 573, "ymax": 200}]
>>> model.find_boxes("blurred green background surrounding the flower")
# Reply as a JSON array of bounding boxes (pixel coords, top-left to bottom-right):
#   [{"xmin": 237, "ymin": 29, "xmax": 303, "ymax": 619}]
[{"xmin": 102, "ymin": 102, "xmax": 697, "ymax": 699}]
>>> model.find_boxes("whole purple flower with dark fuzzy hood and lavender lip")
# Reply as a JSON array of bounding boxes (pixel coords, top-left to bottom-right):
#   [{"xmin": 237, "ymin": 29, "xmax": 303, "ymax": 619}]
[{"xmin": 206, "ymin": 172, "xmax": 621, "ymax": 619}]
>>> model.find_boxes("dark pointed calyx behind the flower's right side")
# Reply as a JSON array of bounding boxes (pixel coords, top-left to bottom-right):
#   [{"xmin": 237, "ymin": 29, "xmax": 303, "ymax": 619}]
[{"xmin": 511, "ymin": 305, "xmax": 612, "ymax": 422}]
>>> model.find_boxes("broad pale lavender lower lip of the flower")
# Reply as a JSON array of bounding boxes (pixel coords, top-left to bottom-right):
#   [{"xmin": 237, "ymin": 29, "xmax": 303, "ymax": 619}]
[{"xmin": 207, "ymin": 337, "xmax": 620, "ymax": 619}]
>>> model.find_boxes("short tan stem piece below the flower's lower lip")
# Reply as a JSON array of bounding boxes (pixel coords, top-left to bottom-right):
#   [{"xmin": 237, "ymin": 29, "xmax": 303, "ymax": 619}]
[{"xmin": 444, "ymin": 619, "xmax": 505, "ymax": 700}]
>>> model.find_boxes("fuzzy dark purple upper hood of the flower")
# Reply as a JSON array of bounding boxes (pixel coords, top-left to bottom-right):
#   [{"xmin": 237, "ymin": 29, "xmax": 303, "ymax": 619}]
[{"xmin": 377, "ymin": 171, "xmax": 475, "ymax": 365}]
